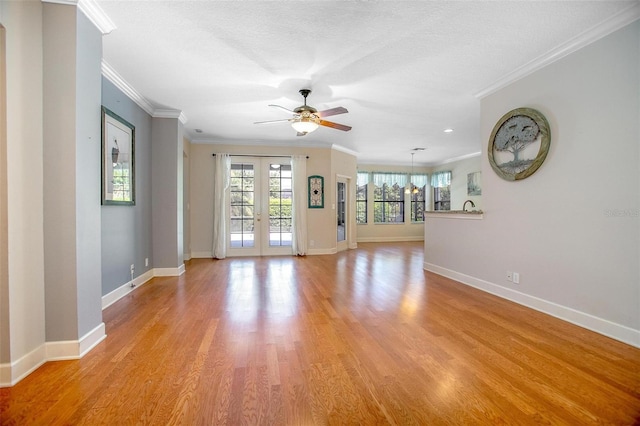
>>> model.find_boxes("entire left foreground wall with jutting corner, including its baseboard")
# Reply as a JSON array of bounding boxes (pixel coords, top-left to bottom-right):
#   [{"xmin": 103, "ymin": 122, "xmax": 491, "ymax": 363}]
[{"xmin": 0, "ymin": 1, "xmax": 104, "ymax": 386}]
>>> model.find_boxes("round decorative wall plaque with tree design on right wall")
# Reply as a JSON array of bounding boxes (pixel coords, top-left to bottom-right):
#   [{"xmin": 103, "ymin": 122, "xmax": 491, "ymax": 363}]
[{"xmin": 487, "ymin": 108, "xmax": 551, "ymax": 180}]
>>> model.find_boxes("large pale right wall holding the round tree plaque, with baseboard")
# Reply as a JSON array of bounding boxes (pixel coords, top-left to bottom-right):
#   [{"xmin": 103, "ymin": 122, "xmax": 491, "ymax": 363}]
[{"xmin": 425, "ymin": 22, "xmax": 640, "ymax": 346}]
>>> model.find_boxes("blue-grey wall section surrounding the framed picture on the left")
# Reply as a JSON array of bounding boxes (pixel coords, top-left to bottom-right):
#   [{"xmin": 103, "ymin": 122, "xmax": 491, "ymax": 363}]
[{"xmin": 101, "ymin": 77, "xmax": 153, "ymax": 296}]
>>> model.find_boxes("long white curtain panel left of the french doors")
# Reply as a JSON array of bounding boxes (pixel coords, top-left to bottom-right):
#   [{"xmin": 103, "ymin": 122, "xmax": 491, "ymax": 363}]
[{"xmin": 213, "ymin": 154, "xmax": 231, "ymax": 259}]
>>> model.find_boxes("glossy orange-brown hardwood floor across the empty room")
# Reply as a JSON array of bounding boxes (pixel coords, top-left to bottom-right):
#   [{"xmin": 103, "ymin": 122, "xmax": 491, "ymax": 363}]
[{"xmin": 0, "ymin": 243, "xmax": 640, "ymax": 425}]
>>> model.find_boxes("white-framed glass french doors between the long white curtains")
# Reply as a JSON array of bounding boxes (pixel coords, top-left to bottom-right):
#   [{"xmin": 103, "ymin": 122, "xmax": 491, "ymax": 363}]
[{"xmin": 227, "ymin": 156, "xmax": 293, "ymax": 256}]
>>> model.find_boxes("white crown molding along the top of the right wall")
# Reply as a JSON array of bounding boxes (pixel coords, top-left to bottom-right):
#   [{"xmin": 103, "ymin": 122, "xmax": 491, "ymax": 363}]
[{"xmin": 474, "ymin": 2, "xmax": 640, "ymax": 99}]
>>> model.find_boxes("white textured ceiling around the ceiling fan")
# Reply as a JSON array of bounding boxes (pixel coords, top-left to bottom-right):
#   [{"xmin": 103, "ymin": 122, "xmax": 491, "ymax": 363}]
[{"xmin": 96, "ymin": 0, "xmax": 637, "ymax": 165}]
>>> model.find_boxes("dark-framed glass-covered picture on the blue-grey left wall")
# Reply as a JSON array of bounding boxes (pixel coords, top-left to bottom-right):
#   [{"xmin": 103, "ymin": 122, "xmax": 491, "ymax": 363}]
[{"xmin": 102, "ymin": 107, "xmax": 136, "ymax": 206}]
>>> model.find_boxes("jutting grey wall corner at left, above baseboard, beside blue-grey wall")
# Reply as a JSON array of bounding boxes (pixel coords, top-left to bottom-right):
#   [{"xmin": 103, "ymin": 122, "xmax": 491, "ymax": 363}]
[{"xmin": 43, "ymin": 3, "xmax": 102, "ymax": 342}]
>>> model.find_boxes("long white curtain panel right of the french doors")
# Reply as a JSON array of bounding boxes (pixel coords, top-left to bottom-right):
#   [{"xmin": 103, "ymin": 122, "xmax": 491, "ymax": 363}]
[{"xmin": 291, "ymin": 155, "xmax": 307, "ymax": 256}]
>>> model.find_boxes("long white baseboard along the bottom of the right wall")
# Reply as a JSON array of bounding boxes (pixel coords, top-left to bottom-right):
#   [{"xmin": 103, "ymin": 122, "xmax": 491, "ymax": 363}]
[{"xmin": 423, "ymin": 262, "xmax": 640, "ymax": 348}]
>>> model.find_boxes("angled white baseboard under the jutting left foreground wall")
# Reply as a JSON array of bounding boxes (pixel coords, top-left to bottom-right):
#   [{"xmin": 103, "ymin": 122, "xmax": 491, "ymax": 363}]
[{"xmin": 0, "ymin": 323, "xmax": 107, "ymax": 387}]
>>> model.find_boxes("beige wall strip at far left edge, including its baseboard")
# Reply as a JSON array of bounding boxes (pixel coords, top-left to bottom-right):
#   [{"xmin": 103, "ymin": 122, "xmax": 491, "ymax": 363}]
[{"xmin": 0, "ymin": 1, "xmax": 45, "ymax": 384}]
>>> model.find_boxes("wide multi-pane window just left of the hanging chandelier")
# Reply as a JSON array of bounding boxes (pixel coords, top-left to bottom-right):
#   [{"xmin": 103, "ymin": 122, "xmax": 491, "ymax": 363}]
[{"xmin": 373, "ymin": 173, "xmax": 407, "ymax": 223}]
